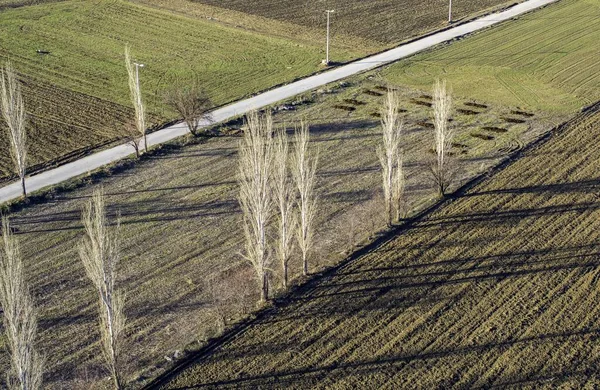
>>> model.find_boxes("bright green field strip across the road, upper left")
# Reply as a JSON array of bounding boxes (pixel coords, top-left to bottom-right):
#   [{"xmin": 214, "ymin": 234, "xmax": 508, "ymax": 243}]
[{"xmin": 0, "ymin": 0, "xmax": 355, "ymax": 109}]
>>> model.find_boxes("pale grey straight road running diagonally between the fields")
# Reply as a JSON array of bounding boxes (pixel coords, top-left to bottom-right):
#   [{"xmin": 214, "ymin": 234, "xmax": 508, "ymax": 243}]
[{"xmin": 0, "ymin": 0, "xmax": 560, "ymax": 204}]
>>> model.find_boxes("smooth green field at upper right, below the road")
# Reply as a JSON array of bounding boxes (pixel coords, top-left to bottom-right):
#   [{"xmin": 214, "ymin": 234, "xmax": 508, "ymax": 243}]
[{"xmin": 382, "ymin": 0, "xmax": 600, "ymax": 113}]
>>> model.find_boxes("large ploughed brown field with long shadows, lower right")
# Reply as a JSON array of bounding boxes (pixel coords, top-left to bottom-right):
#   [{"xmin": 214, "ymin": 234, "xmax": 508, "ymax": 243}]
[{"xmin": 157, "ymin": 101, "xmax": 600, "ymax": 389}]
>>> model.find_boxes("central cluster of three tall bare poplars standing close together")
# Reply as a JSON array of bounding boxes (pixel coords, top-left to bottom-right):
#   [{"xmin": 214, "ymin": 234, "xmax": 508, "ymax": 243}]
[{"xmin": 239, "ymin": 112, "xmax": 317, "ymax": 302}]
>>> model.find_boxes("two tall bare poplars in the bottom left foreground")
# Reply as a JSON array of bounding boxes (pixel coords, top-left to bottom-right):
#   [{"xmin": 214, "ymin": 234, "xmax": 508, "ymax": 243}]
[{"xmin": 0, "ymin": 190, "xmax": 125, "ymax": 390}]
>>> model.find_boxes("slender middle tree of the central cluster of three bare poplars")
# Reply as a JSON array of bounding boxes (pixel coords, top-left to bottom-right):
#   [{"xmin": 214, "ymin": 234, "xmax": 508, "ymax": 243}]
[{"xmin": 273, "ymin": 127, "xmax": 297, "ymax": 289}]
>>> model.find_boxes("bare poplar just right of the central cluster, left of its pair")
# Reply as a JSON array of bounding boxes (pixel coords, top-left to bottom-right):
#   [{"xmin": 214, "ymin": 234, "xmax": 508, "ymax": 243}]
[{"xmin": 377, "ymin": 89, "xmax": 404, "ymax": 226}]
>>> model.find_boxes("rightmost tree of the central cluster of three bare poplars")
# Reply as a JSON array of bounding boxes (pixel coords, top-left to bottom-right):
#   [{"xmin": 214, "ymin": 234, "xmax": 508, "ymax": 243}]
[{"xmin": 292, "ymin": 122, "xmax": 318, "ymax": 275}]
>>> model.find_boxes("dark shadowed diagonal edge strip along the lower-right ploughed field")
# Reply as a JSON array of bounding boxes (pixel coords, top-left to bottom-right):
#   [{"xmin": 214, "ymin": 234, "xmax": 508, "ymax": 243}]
[{"xmin": 142, "ymin": 96, "xmax": 600, "ymax": 390}]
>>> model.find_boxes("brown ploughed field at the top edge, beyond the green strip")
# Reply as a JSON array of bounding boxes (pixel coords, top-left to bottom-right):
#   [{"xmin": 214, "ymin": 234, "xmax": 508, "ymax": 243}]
[{"xmin": 192, "ymin": 0, "xmax": 515, "ymax": 45}]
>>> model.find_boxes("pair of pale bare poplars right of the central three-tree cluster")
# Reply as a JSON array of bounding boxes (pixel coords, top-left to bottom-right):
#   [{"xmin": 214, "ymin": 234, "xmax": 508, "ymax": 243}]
[{"xmin": 377, "ymin": 80, "xmax": 454, "ymax": 226}]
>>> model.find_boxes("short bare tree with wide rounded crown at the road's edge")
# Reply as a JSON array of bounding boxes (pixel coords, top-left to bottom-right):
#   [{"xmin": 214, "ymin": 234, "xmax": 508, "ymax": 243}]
[{"xmin": 163, "ymin": 81, "xmax": 212, "ymax": 135}]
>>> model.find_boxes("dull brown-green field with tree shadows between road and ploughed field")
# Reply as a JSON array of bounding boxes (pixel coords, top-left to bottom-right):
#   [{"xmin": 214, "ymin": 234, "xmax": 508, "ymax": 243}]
[{"xmin": 0, "ymin": 77, "xmax": 544, "ymax": 388}]
